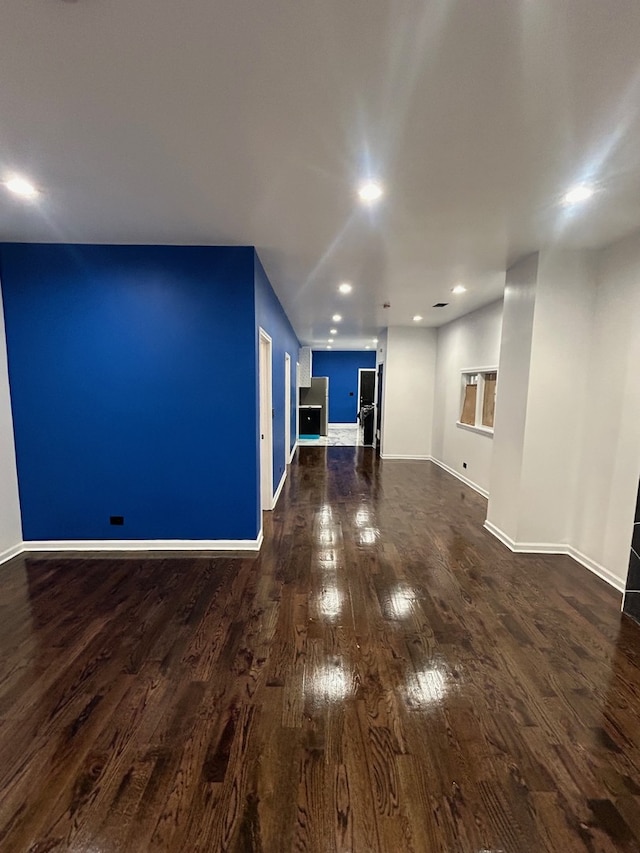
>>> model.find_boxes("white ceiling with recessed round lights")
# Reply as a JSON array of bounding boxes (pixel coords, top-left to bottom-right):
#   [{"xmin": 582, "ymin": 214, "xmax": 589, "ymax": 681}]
[{"xmin": 0, "ymin": 0, "xmax": 640, "ymax": 348}]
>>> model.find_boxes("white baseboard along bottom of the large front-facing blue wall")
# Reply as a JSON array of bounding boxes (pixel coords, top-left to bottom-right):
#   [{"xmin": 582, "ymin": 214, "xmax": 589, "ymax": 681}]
[{"xmin": 21, "ymin": 529, "xmax": 264, "ymax": 556}]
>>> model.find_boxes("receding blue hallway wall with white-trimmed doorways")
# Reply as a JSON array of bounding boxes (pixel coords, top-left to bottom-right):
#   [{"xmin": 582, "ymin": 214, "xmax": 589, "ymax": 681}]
[{"xmin": 255, "ymin": 253, "xmax": 300, "ymax": 492}]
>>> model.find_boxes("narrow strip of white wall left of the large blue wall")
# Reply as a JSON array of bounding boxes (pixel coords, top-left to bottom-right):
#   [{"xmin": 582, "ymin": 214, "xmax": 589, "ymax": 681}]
[{"xmin": 0, "ymin": 282, "xmax": 22, "ymax": 560}]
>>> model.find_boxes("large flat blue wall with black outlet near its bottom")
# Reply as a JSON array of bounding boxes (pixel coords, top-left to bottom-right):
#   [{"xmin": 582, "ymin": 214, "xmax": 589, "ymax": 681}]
[{"xmin": 0, "ymin": 244, "xmax": 262, "ymax": 540}]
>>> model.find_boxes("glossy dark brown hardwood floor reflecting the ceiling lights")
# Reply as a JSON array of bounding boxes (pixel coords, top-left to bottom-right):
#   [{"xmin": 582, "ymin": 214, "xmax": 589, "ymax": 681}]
[{"xmin": 0, "ymin": 447, "xmax": 640, "ymax": 853}]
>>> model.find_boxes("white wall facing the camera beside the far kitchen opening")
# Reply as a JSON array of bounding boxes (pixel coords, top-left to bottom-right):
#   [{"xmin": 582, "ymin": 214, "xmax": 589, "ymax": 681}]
[{"xmin": 379, "ymin": 326, "xmax": 436, "ymax": 459}]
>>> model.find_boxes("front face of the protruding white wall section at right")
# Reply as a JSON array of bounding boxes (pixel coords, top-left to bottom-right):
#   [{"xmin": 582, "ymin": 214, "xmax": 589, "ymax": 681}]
[{"xmin": 516, "ymin": 249, "xmax": 597, "ymax": 545}]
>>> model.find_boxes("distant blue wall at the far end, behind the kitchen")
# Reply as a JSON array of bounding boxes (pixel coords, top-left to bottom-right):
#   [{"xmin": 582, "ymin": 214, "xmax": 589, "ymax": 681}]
[{"xmin": 312, "ymin": 350, "xmax": 376, "ymax": 424}]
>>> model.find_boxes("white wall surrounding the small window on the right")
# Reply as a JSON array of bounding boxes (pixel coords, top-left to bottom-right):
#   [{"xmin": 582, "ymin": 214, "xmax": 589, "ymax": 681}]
[{"xmin": 433, "ymin": 300, "xmax": 503, "ymax": 494}]
